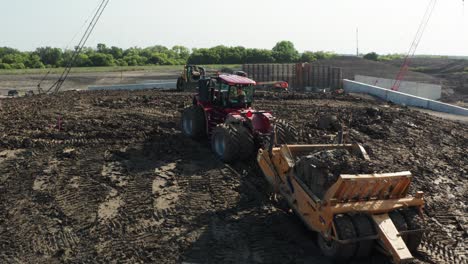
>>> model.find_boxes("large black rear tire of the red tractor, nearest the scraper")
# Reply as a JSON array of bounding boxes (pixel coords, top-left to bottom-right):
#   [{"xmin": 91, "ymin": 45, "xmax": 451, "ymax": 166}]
[{"xmin": 211, "ymin": 124, "xmax": 254, "ymax": 163}]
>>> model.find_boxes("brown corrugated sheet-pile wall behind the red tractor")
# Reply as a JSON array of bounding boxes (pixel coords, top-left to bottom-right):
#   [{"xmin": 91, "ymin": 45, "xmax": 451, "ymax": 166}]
[{"xmin": 242, "ymin": 63, "xmax": 343, "ymax": 90}]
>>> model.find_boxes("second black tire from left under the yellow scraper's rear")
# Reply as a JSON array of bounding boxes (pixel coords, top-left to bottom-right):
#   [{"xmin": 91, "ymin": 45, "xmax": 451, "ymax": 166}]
[{"xmin": 351, "ymin": 214, "xmax": 377, "ymax": 258}]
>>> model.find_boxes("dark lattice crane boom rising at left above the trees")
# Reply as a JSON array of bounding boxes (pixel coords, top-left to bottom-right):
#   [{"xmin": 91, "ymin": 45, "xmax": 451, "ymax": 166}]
[{"xmin": 47, "ymin": 0, "xmax": 110, "ymax": 93}]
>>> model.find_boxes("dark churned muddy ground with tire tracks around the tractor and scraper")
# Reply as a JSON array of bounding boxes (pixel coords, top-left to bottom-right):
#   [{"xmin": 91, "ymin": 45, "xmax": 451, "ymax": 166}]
[{"xmin": 0, "ymin": 91, "xmax": 468, "ymax": 263}]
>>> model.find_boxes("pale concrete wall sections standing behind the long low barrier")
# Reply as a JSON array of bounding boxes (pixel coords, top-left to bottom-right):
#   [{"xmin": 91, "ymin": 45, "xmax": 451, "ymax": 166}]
[{"xmin": 354, "ymin": 75, "xmax": 442, "ymax": 100}]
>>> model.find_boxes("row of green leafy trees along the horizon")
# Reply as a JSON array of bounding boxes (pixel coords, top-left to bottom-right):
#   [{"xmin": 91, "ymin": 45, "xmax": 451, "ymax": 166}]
[{"xmin": 0, "ymin": 41, "xmax": 335, "ymax": 69}]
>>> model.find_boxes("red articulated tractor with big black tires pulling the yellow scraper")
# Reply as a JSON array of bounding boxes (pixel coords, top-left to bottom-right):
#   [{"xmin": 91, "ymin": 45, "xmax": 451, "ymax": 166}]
[{"xmin": 181, "ymin": 74, "xmax": 297, "ymax": 163}]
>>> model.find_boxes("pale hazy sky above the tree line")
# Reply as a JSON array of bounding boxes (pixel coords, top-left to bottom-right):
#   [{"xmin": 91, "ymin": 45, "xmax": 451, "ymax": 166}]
[{"xmin": 0, "ymin": 0, "xmax": 468, "ymax": 55}]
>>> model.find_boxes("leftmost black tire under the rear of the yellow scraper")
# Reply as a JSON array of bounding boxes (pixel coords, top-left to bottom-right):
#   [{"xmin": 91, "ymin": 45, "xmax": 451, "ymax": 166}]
[{"xmin": 318, "ymin": 214, "xmax": 358, "ymax": 262}]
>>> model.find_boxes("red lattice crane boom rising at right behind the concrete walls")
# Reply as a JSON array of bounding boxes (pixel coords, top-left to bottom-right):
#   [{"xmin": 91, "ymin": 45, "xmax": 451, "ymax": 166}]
[{"xmin": 392, "ymin": 0, "xmax": 437, "ymax": 91}]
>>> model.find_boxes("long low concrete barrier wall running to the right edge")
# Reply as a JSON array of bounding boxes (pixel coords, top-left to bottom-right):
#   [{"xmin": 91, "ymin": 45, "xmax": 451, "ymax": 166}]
[{"xmin": 343, "ymin": 80, "xmax": 468, "ymax": 116}]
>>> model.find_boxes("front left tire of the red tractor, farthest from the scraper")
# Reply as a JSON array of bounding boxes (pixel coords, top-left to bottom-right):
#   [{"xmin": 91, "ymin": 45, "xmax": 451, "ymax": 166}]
[{"xmin": 181, "ymin": 106, "xmax": 206, "ymax": 139}]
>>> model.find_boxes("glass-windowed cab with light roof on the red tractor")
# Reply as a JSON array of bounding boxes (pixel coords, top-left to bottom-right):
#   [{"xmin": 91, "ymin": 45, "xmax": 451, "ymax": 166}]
[{"xmin": 198, "ymin": 74, "xmax": 256, "ymax": 109}]
